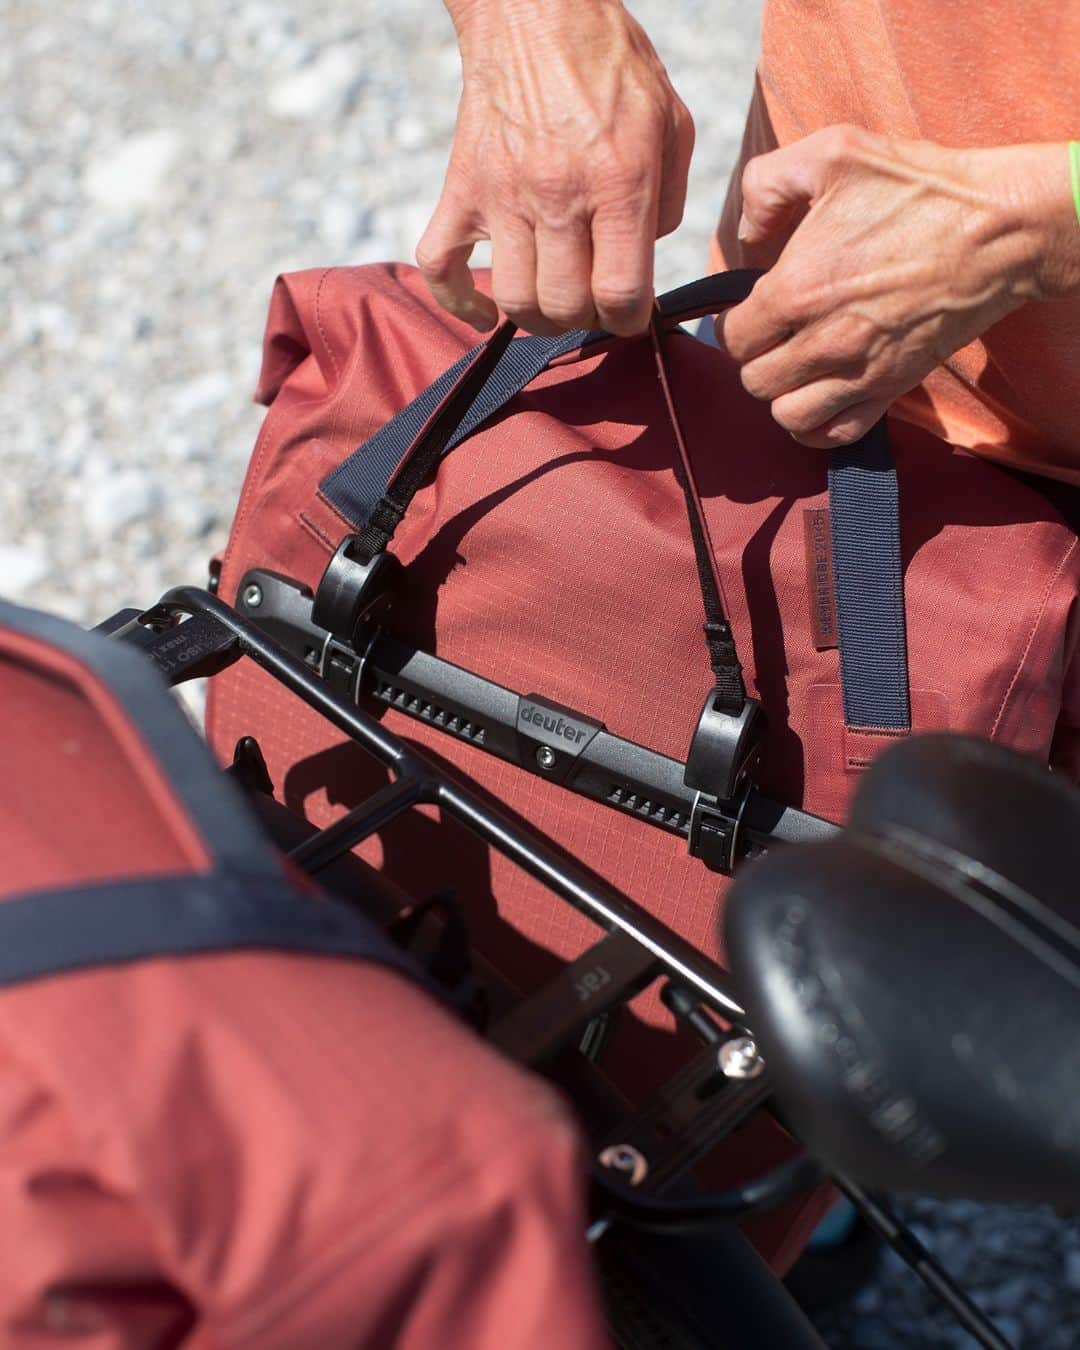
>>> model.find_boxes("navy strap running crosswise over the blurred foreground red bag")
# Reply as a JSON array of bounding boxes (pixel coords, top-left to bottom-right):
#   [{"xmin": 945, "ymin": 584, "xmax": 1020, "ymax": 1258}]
[{"xmin": 0, "ymin": 872, "xmax": 431, "ymax": 988}]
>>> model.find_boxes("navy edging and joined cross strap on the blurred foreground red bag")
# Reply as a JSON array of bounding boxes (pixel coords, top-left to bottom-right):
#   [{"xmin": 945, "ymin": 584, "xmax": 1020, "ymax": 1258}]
[{"xmin": 0, "ymin": 601, "xmax": 435, "ymax": 991}]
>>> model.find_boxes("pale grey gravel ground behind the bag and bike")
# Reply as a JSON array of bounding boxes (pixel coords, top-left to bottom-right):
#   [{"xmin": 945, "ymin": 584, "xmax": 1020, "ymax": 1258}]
[{"xmin": 0, "ymin": 0, "xmax": 1080, "ymax": 1350}]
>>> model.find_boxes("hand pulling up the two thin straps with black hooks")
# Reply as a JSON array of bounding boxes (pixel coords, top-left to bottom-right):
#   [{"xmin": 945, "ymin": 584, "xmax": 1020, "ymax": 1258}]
[{"xmin": 416, "ymin": 0, "xmax": 694, "ymax": 335}]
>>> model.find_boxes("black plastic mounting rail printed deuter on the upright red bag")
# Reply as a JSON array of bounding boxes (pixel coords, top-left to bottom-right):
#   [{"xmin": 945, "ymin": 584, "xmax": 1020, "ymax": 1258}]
[{"xmin": 236, "ymin": 568, "xmax": 836, "ymax": 873}]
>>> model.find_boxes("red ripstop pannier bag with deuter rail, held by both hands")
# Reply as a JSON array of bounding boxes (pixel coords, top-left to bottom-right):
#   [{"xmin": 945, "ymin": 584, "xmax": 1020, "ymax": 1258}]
[{"xmin": 208, "ymin": 257, "xmax": 1080, "ymax": 1270}]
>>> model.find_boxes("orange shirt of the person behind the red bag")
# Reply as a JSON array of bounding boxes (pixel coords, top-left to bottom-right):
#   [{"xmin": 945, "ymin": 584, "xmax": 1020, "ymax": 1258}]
[{"xmin": 713, "ymin": 0, "xmax": 1080, "ymax": 483}]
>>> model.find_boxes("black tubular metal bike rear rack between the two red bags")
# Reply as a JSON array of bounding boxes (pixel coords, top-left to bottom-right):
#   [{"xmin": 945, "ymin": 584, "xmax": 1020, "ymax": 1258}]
[{"xmin": 99, "ymin": 586, "xmax": 1010, "ymax": 1350}]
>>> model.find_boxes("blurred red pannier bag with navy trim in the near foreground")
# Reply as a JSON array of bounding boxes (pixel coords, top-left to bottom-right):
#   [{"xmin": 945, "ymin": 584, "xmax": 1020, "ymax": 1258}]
[{"xmin": 0, "ymin": 605, "xmax": 608, "ymax": 1350}]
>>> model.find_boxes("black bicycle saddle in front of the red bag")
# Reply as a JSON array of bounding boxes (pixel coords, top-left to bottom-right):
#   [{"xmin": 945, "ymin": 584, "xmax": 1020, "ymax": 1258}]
[{"xmin": 725, "ymin": 736, "xmax": 1080, "ymax": 1206}]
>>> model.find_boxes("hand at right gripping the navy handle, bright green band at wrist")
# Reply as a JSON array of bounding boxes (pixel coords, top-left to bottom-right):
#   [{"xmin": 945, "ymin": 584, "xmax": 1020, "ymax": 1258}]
[{"xmin": 717, "ymin": 127, "xmax": 1080, "ymax": 448}]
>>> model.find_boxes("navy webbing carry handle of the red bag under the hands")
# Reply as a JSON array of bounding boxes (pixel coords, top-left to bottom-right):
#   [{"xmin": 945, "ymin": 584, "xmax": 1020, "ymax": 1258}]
[{"xmin": 319, "ymin": 269, "xmax": 911, "ymax": 732}]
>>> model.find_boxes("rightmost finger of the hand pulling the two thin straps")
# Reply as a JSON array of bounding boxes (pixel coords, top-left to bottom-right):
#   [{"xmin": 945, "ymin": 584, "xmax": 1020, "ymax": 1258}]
[{"xmin": 593, "ymin": 189, "xmax": 657, "ymax": 338}]
